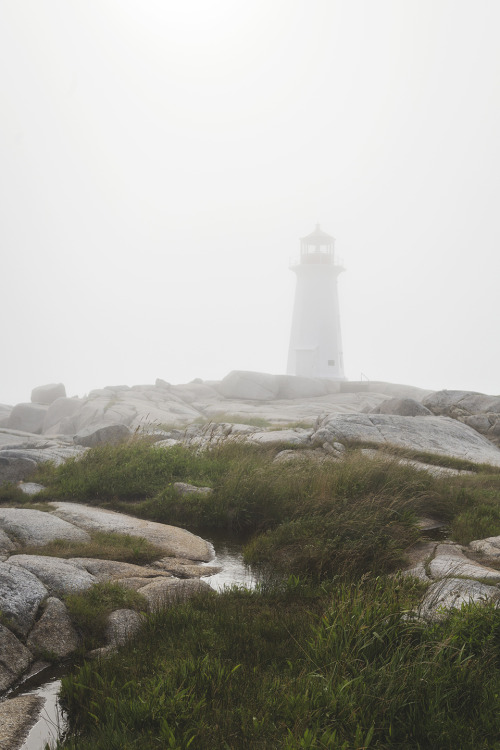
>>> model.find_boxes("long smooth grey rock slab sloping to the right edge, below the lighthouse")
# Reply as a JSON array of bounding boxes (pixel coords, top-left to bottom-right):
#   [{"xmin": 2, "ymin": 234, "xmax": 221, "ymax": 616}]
[{"xmin": 311, "ymin": 414, "xmax": 500, "ymax": 466}]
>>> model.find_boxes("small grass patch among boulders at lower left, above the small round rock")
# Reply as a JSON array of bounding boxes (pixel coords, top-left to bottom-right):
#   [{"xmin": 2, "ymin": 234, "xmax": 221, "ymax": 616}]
[{"xmin": 64, "ymin": 583, "xmax": 147, "ymax": 652}]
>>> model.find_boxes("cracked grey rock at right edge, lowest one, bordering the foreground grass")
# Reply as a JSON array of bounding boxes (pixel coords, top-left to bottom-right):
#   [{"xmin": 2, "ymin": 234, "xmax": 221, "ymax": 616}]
[{"xmin": 419, "ymin": 578, "xmax": 500, "ymax": 622}]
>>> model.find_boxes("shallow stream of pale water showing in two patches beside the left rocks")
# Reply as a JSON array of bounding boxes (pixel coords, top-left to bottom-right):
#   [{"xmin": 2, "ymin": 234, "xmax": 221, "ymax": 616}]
[{"xmin": 12, "ymin": 535, "xmax": 257, "ymax": 750}]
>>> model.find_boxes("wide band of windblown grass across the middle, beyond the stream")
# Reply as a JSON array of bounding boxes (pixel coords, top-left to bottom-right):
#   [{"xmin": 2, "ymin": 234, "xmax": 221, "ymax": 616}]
[{"xmin": 37, "ymin": 440, "xmax": 500, "ymax": 578}]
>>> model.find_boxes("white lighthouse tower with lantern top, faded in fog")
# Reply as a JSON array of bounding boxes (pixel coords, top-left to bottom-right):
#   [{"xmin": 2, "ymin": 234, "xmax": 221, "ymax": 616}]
[{"xmin": 287, "ymin": 224, "xmax": 345, "ymax": 380}]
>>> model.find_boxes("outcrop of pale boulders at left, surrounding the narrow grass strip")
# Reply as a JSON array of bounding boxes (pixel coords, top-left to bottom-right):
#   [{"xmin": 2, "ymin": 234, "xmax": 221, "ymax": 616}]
[{"xmin": 0, "ymin": 503, "xmax": 220, "ymax": 712}]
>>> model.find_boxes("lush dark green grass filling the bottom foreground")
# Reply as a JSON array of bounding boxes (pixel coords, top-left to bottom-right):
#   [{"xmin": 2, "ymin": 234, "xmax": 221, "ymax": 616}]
[{"xmin": 59, "ymin": 579, "xmax": 500, "ymax": 750}]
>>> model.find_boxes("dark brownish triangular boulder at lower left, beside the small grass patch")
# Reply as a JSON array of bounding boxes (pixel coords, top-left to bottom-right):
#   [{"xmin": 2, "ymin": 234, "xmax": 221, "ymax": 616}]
[{"xmin": 26, "ymin": 596, "xmax": 79, "ymax": 659}]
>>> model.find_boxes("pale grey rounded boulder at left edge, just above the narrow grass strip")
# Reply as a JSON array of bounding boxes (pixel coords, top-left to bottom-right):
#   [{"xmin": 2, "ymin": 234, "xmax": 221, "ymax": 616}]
[{"xmin": 0, "ymin": 507, "xmax": 90, "ymax": 547}]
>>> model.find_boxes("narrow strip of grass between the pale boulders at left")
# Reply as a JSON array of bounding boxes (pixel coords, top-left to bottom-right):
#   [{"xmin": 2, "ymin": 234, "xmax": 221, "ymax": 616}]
[{"xmin": 16, "ymin": 531, "xmax": 165, "ymax": 565}]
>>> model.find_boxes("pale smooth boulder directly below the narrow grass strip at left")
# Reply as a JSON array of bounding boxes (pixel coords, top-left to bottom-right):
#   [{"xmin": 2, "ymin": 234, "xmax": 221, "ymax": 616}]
[{"xmin": 8, "ymin": 555, "xmax": 97, "ymax": 596}]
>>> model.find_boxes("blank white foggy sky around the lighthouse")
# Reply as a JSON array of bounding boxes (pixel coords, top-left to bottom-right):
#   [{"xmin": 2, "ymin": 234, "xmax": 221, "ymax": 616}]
[{"xmin": 0, "ymin": 0, "xmax": 500, "ymax": 403}]
